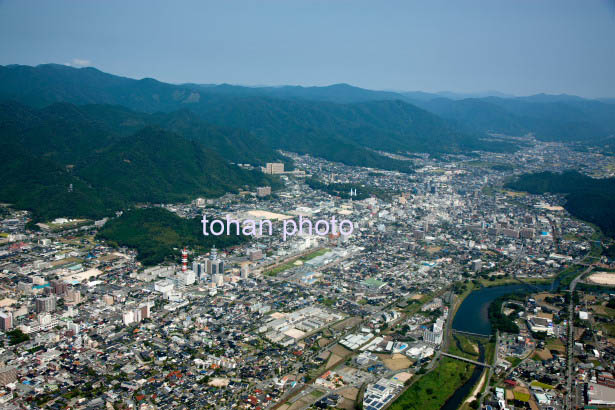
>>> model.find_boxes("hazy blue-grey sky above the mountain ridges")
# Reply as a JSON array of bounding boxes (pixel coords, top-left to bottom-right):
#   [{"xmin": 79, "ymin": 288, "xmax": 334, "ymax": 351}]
[{"xmin": 0, "ymin": 0, "xmax": 615, "ymax": 97}]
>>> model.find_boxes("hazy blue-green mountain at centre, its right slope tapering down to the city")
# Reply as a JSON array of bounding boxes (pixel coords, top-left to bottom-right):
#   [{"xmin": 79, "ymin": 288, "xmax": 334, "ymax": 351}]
[{"xmin": 191, "ymin": 98, "xmax": 514, "ymax": 161}]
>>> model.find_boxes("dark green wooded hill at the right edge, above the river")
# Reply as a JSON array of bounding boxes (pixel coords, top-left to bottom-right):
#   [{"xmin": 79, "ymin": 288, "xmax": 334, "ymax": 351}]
[{"xmin": 506, "ymin": 171, "xmax": 615, "ymax": 237}]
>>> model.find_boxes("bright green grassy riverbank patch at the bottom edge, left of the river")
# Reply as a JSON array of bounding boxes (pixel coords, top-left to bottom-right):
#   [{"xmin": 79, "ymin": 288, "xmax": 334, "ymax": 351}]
[{"xmin": 390, "ymin": 357, "xmax": 474, "ymax": 410}]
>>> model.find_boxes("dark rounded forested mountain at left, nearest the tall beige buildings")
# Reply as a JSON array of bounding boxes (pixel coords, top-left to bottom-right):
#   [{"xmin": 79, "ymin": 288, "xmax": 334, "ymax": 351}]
[{"xmin": 79, "ymin": 127, "xmax": 268, "ymax": 202}]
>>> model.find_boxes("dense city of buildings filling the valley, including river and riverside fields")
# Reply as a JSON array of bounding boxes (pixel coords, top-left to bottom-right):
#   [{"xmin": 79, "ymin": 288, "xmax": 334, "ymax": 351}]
[{"xmin": 0, "ymin": 139, "xmax": 615, "ymax": 410}]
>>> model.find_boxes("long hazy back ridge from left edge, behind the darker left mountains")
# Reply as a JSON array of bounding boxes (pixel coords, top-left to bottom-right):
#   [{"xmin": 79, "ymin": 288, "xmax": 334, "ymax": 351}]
[{"xmin": 0, "ymin": 64, "xmax": 514, "ymax": 169}]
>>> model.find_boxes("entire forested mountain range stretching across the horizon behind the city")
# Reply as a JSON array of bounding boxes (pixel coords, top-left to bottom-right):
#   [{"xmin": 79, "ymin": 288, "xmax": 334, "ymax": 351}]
[{"xmin": 0, "ymin": 64, "xmax": 615, "ymax": 219}]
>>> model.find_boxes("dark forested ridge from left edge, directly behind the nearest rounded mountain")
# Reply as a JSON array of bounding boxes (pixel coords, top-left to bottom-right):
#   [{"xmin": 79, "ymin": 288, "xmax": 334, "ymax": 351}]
[{"xmin": 0, "ymin": 102, "xmax": 285, "ymax": 165}]
